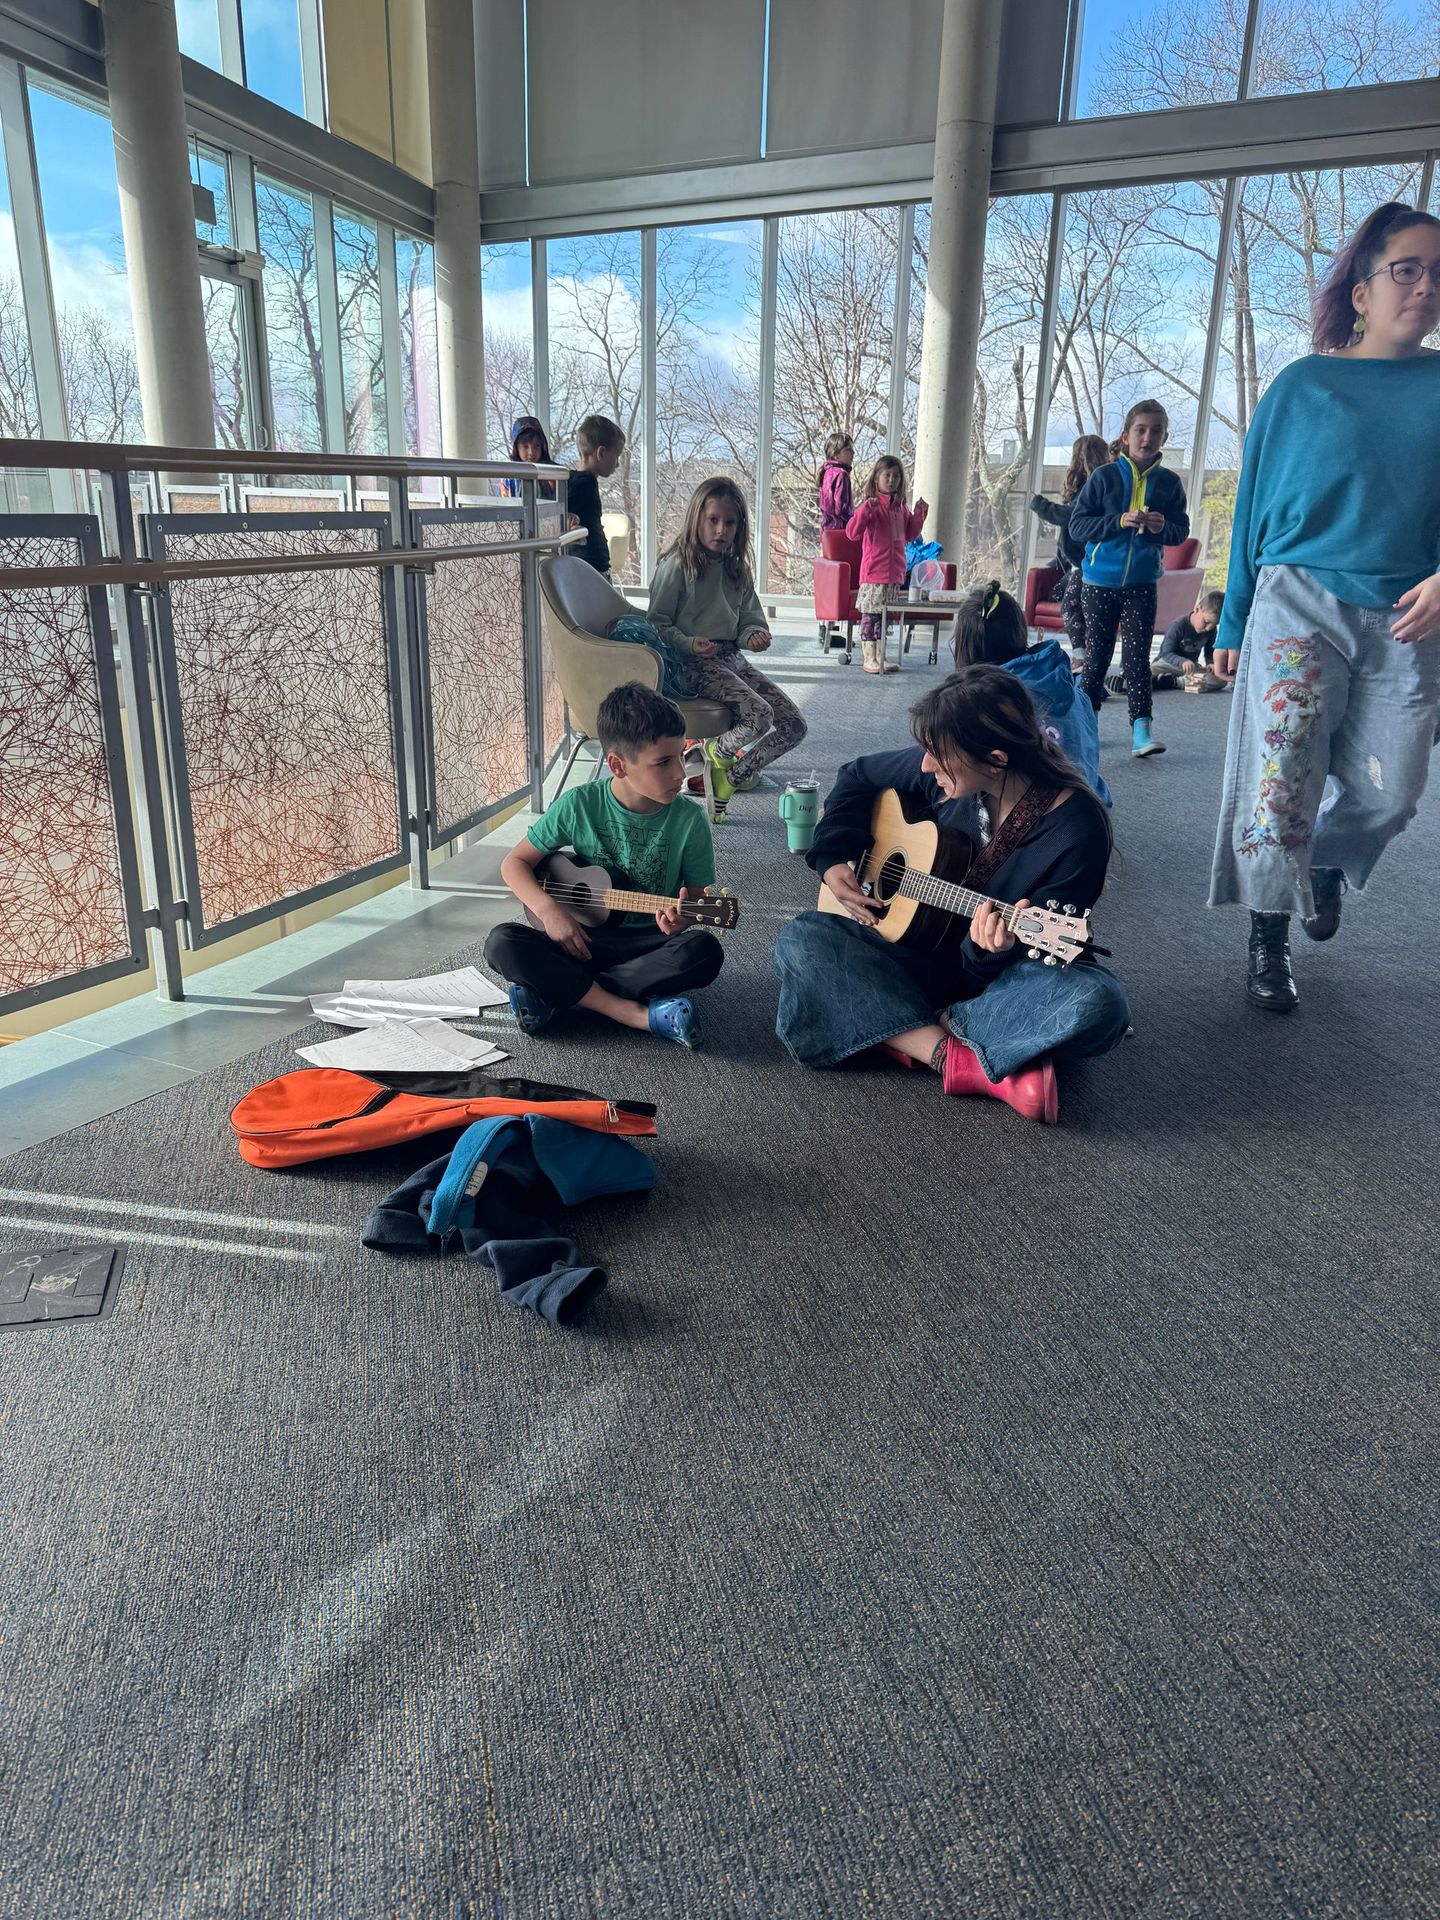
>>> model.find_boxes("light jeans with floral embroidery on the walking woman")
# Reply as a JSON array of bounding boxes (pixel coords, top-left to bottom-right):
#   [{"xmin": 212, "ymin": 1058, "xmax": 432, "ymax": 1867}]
[{"xmin": 1210, "ymin": 566, "xmax": 1440, "ymax": 916}]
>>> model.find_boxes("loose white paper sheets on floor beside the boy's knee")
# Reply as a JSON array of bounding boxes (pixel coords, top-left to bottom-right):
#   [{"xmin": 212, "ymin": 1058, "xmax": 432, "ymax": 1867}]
[{"xmin": 300, "ymin": 966, "xmax": 507, "ymax": 1073}]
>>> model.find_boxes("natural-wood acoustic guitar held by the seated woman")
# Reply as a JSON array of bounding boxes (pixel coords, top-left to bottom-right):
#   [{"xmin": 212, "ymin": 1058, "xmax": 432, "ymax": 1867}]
[{"xmin": 816, "ymin": 789, "xmax": 1106, "ymax": 966}]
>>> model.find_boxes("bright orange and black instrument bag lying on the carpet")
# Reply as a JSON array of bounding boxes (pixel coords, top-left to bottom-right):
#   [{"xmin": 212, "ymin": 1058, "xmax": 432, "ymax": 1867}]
[{"xmin": 230, "ymin": 1068, "xmax": 655, "ymax": 1167}]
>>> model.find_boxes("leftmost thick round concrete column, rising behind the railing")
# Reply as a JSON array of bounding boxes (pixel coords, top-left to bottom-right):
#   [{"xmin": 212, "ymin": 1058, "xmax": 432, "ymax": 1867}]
[{"xmin": 102, "ymin": 0, "xmax": 215, "ymax": 447}]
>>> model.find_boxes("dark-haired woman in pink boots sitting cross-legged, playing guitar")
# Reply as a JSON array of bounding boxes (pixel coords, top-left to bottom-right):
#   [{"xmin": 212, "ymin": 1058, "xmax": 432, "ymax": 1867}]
[{"xmin": 776, "ymin": 666, "xmax": 1129, "ymax": 1123}]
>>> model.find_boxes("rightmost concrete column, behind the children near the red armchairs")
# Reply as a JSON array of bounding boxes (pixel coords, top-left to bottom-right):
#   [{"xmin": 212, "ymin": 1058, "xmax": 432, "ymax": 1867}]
[{"xmin": 917, "ymin": 0, "xmax": 1002, "ymax": 561}]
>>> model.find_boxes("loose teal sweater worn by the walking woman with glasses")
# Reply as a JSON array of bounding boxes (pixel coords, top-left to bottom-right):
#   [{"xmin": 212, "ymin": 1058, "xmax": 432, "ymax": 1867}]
[{"xmin": 1215, "ymin": 353, "xmax": 1440, "ymax": 647}]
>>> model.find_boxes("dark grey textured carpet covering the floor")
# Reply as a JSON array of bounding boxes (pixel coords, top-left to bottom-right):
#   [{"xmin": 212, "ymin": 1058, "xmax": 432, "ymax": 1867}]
[{"xmin": 0, "ymin": 643, "xmax": 1440, "ymax": 1920}]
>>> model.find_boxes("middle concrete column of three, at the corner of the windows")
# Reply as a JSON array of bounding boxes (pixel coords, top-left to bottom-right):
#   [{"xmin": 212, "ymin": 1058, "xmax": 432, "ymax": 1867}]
[{"xmin": 424, "ymin": 0, "xmax": 486, "ymax": 461}]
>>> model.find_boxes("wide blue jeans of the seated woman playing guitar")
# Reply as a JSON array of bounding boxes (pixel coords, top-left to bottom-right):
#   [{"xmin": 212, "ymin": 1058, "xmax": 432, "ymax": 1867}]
[{"xmin": 776, "ymin": 914, "xmax": 1131, "ymax": 1081}]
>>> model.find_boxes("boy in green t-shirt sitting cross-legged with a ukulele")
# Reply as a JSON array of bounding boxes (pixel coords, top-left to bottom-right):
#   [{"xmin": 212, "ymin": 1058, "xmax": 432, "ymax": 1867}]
[{"xmin": 486, "ymin": 682, "xmax": 724, "ymax": 1046}]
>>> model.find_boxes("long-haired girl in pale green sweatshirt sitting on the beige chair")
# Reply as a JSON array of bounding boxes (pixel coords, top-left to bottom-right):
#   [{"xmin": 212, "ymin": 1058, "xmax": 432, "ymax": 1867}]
[{"xmin": 649, "ymin": 487, "xmax": 804, "ymax": 804}]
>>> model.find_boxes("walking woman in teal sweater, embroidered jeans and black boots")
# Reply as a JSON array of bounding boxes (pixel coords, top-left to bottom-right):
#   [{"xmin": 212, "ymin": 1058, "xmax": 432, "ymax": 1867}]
[{"xmin": 1210, "ymin": 204, "xmax": 1440, "ymax": 1014}]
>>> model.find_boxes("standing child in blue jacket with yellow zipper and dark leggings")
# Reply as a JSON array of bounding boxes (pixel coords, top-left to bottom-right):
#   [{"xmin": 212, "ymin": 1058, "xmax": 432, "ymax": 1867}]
[{"xmin": 1069, "ymin": 399, "xmax": 1190, "ymax": 760}]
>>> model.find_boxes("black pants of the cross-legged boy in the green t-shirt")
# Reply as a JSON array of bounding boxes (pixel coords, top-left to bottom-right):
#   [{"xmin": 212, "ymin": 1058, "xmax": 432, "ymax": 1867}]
[{"xmin": 486, "ymin": 920, "xmax": 726, "ymax": 1006}]
